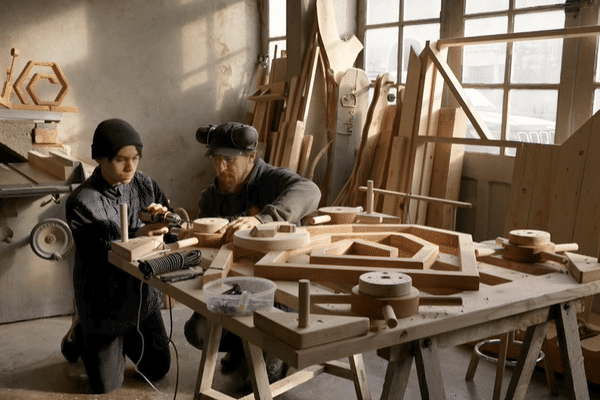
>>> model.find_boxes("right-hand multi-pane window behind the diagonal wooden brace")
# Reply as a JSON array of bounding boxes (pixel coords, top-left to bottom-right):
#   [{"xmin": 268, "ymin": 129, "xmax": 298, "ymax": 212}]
[{"xmin": 462, "ymin": 0, "xmax": 565, "ymax": 155}]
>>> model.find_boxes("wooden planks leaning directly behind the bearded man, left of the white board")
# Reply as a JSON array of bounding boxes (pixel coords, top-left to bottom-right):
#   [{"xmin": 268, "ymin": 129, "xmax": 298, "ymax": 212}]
[{"xmin": 249, "ymin": 0, "xmax": 363, "ymax": 178}]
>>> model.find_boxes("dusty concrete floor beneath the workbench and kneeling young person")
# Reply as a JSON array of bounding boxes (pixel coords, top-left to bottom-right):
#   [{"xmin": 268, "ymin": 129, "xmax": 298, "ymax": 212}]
[{"xmin": 0, "ymin": 305, "xmax": 600, "ymax": 400}]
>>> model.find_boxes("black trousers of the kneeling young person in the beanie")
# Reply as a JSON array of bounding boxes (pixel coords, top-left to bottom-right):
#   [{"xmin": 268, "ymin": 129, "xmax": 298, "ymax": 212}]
[{"xmin": 76, "ymin": 310, "xmax": 171, "ymax": 394}]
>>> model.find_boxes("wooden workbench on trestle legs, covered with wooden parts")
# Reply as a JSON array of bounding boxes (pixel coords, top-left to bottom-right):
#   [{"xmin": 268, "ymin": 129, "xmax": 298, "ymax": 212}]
[{"xmin": 109, "ymin": 228, "xmax": 600, "ymax": 399}]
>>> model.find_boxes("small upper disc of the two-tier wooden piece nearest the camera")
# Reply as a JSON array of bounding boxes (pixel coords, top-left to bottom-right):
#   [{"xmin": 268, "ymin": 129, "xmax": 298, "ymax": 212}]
[{"xmin": 358, "ymin": 271, "xmax": 412, "ymax": 297}]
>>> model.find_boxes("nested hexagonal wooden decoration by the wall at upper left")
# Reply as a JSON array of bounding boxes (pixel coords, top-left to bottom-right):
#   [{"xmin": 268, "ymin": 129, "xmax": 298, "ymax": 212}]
[{"xmin": 13, "ymin": 61, "xmax": 70, "ymax": 106}]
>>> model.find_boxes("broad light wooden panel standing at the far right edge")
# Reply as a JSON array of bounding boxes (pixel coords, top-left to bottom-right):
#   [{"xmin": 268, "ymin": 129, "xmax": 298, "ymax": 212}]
[{"xmin": 505, "ymin": 112, "xmax": 600, "ymax": 256}]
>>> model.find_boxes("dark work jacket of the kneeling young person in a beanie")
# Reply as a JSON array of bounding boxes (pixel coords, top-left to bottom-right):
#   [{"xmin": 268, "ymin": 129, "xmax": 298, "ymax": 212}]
[{"xmin": 66, "ymin": 167, "xmax": 168, "ymax": 336}]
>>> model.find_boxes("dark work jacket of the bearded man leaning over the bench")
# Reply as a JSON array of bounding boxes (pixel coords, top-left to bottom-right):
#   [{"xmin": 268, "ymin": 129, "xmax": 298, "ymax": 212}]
[{"xmin": 198, "ymin": 158, "xmax": 321, "ymax": 223}]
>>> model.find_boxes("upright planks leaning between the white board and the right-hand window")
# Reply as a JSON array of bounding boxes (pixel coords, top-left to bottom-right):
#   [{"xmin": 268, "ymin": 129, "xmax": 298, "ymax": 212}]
[{"xmin": 333, "ymin": 45, "xmax": 466, "ymax": 229}]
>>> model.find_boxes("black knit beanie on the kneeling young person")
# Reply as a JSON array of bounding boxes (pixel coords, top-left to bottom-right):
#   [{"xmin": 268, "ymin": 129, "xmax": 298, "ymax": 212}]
[{"xmin": 92, "ymin": 118, "xmax": 143, "ymax": 159}]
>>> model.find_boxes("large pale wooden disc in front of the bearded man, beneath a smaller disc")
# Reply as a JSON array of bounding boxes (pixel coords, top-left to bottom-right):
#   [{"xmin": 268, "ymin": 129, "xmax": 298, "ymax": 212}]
[{"xmin": 233, "ymin": 228, "xmax": 310, "ymax": 254}]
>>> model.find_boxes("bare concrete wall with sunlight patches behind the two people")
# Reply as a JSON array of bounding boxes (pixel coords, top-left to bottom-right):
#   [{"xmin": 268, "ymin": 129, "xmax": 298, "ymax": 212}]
[{"xmin": 0, "ymin": 0, "xmax": 260, "ymax": 216}]
